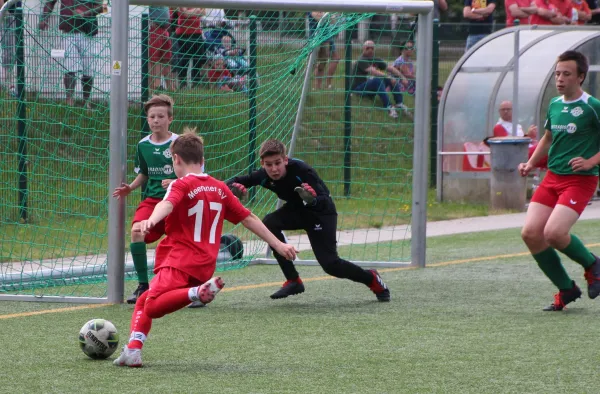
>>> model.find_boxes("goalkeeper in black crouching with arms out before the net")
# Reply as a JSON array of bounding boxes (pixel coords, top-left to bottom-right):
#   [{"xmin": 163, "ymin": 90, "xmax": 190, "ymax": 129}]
[{"xmin": 227, "ymin": 140, "xmax": 390, "ymax": 301}]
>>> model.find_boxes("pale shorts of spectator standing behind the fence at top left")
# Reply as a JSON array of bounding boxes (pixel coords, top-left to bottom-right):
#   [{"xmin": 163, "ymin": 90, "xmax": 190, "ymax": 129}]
[{"xmin": 63, "ymin": 33, "xmax": 98, "ymax": 77}]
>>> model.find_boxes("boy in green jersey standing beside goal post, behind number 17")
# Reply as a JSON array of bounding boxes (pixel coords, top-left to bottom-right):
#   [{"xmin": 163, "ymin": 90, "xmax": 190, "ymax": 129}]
[{"xmin": 113, "ymin": 94, "xmax": 178, "ymax": 304}]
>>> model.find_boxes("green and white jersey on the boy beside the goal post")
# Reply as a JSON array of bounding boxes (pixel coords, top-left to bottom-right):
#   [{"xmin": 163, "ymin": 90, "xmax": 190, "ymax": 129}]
[{"xmin": 135, "ymin": 133, "xmax": 179, "ymax": 198}]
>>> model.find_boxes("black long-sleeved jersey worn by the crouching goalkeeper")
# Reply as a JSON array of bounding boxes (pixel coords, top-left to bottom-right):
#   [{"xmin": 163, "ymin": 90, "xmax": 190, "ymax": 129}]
[{"xmin": 226, "ymin": 159, "xmax": 336, "ymax": 214}]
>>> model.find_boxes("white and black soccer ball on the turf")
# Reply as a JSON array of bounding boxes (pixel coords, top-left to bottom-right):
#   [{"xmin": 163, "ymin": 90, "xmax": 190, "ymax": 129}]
[{"xmin": 79, "ymin": 319, "xmax": 119, "ymax": 360}]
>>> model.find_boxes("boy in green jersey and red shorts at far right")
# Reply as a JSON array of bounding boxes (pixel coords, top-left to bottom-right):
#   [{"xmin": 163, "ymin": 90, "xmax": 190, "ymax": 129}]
[{"xmin": 519, "ymin": 51, "xmax": 600, "ymax": 311}]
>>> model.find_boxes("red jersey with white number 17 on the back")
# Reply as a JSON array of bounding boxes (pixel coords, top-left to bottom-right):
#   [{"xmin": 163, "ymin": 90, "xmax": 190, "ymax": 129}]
[{"xmin": 154, "ymin": 174, "xmax": 250, "ymax": 280}]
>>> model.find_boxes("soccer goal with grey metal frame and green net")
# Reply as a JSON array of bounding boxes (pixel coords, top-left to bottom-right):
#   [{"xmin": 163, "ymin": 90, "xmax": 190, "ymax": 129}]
[{"xmin": 0, "ymin": 0, "xmax": 433, "ymax": 303}]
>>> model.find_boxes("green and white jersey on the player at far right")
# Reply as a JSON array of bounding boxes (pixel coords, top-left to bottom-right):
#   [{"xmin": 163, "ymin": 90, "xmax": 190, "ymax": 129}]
[{"xmin": 544, "ymin": 92, "xmax": 600, "ymax": 175}]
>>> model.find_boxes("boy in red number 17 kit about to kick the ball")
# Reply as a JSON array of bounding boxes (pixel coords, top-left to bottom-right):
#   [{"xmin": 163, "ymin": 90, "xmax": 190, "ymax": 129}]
[{"xmin": 114, "ymin": 130, "xmax": 297, "ymax": 367}]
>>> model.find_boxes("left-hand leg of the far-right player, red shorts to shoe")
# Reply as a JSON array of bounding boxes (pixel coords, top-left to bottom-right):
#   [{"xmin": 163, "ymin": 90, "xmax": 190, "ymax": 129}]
[{"xmin": 521, "ymin": 172, "xmax": 581, "ymax": 311}]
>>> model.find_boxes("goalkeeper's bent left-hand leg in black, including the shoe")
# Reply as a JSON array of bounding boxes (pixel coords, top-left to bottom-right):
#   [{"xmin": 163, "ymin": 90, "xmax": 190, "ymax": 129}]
[{"xmin": 263, "ymin": 205, "xmax": 304, "ymax": 299}]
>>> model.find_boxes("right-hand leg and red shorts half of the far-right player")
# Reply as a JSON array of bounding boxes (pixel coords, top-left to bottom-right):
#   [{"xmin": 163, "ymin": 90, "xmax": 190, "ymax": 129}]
[{"xmin": 544, "ymin": 175, "xmax": 600, "ymax": 299}]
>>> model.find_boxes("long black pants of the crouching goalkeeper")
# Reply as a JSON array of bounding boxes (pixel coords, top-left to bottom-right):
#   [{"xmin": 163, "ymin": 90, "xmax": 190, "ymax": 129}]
[{"xmin": 263, "ymin": 205, "xmax": 373, "ymax": 286}]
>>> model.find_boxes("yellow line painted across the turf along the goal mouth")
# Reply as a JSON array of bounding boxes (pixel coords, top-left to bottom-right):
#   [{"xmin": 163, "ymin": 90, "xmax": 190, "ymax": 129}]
[{"xmin": 0, "ymin": 243, "xmax": 600, "ymax": 320}]
